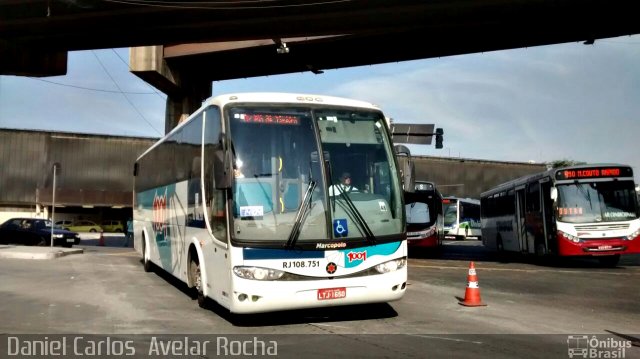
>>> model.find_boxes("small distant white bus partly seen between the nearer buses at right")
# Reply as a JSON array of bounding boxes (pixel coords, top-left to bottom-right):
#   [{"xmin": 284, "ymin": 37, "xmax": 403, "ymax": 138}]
[{"xmin": 442, "ymin": 197, "xmax": 481, "ymax": 240}]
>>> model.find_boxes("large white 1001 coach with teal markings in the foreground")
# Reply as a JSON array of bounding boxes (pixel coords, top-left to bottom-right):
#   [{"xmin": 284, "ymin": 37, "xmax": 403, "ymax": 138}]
[{"xmin": 134, "ymin": 93, "xmax": 407, "ymax": 313}]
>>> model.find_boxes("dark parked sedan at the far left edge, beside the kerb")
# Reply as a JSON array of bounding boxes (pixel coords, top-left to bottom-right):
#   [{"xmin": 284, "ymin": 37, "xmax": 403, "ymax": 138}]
[{"xmin": 0, "ymin": 218, "xmax": 80, "ymax": 247}]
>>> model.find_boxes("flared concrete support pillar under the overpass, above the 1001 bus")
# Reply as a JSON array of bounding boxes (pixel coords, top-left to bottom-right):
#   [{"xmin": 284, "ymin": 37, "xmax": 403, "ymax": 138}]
[{"xmin": 129, "ymin": 46, "xmax": 212, "ymax": 133}]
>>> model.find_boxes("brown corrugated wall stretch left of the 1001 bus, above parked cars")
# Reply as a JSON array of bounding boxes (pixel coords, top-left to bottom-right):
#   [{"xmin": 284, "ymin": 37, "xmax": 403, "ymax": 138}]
[{"xmin": 0, "ymin": 130, "xmax": 156, "ymax": 206}]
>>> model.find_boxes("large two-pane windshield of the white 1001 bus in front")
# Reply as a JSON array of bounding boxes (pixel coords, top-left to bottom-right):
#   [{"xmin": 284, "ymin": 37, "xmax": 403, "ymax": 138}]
[{"xmin": 227, "ymin": 105, "xmax": 403, "ymax": 243}]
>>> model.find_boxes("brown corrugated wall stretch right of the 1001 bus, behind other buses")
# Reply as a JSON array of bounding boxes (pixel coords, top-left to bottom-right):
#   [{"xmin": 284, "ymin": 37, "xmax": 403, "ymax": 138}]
[{"xmin": 399, "ymin": 156, "xmax": 546, "ymax": 199}]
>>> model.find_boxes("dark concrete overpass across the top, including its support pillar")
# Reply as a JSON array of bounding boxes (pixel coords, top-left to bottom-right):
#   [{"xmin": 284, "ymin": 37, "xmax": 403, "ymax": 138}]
[{"xmin": 0, "ymin": 0, "xmax": 640, "ymax": 130}]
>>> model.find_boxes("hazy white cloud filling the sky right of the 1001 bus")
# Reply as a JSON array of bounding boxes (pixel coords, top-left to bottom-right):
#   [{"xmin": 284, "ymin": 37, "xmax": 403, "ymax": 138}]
[{"xmin": 328, "ymin": 38, "xmax": 640, "ymax": 179}]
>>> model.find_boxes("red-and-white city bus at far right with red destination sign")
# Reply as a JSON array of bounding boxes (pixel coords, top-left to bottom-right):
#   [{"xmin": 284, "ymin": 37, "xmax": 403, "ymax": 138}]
[{"xmin": 481, "ymin": 164, "xmax": 640, "ymax": 266}]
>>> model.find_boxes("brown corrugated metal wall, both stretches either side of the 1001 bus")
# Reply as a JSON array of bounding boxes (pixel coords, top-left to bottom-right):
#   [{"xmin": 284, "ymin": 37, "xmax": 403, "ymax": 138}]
[{"xmin": 0, "ymin": 130, "xmax": 546, "ymax": 206}]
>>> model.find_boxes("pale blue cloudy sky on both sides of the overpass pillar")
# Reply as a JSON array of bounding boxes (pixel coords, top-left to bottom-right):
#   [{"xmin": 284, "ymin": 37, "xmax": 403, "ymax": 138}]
[{"xmin": 0, "ymin": 35, "xmax": 640, "ymax": 181}]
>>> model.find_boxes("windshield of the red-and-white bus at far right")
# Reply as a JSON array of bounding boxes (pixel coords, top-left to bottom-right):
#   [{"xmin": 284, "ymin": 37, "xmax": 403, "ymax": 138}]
[{"xmin": 557, "ymin": 181, "xmax": 638, "ymax": 223}]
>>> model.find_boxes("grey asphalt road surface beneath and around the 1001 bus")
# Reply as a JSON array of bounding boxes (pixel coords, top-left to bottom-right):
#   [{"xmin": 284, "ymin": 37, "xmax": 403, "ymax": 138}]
[{"xmin": 0, "ymin": 241, "xmax": 640, "ymax": 358}]
